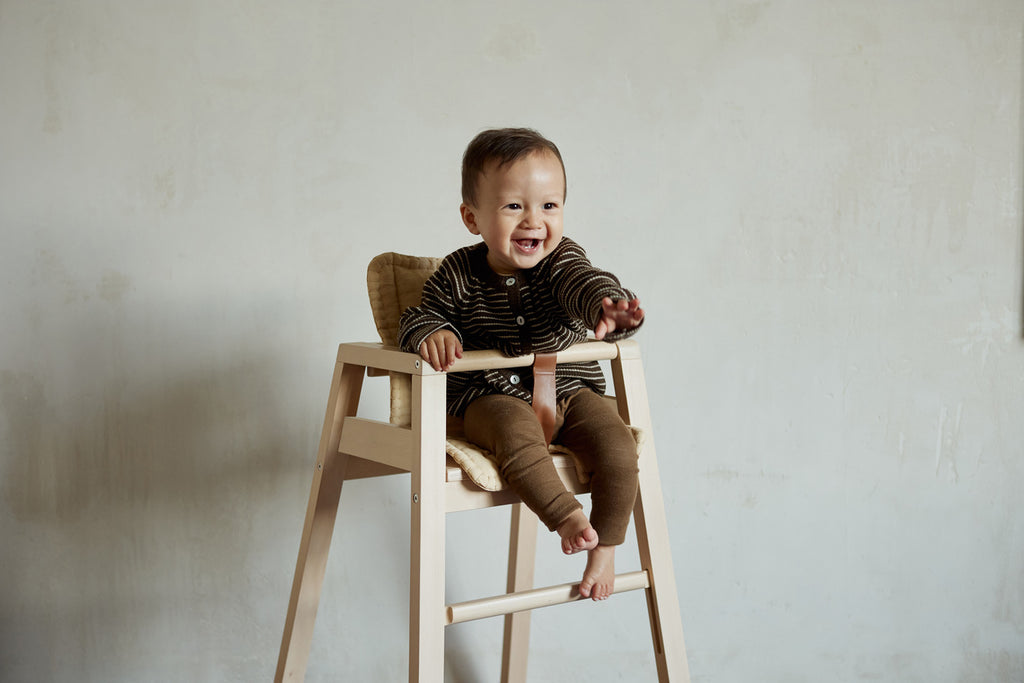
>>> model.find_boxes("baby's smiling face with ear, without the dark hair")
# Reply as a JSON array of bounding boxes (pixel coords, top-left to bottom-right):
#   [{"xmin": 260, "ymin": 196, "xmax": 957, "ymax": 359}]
[{"xmin": 461, "ymin": 152, "xmax": 565, "ymax": 274}]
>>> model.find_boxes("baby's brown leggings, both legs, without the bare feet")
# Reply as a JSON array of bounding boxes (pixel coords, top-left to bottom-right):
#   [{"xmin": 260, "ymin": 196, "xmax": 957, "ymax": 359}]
[{"xmin": 465, "ymin": 389, "xmax": 638, "ymax": 546}]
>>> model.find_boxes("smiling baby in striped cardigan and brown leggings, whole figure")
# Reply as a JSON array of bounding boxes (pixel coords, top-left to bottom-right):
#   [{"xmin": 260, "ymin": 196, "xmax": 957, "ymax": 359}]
[{"xmin": 398, "ymin": 128, "xmax": 644, "ymax": 600}]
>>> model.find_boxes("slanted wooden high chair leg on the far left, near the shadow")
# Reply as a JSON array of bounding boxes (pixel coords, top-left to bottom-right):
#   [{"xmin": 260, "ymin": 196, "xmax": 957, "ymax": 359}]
[{"xmin": 274, "ymin": 361, "xmax": 365, "ymax": 683}]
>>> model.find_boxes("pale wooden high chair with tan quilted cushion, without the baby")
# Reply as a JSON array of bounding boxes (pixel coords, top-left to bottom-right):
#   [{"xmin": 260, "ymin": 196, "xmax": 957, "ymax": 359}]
[{"xmin": 274, "ymin": 254, "xmax": 689, "ymax": 683}]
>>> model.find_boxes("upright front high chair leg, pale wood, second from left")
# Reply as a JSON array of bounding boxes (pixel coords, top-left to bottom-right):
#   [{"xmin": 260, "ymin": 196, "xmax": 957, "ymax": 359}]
[{"xmin": 409, "ymin": 375, "xmax": 446, "ymax": 683}]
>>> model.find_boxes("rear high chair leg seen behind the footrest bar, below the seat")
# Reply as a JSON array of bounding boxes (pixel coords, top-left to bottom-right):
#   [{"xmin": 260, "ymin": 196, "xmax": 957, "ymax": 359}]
[{"xmin": 502, "ymin": 503, "xmax": 539, "ymax": 683}]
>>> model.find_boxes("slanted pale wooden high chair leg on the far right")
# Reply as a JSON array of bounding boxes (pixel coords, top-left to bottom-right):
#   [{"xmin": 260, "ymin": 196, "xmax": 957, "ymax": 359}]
[{"xmin": 611, "ymin": 344, "xmax": 690, "ymax": 683}]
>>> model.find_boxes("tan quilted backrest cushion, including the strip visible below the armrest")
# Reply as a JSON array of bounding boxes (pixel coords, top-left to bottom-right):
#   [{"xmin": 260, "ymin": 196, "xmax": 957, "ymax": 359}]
[{"xmin": 367, "ymin": 252, "xmax": 441, "ymax": 426}]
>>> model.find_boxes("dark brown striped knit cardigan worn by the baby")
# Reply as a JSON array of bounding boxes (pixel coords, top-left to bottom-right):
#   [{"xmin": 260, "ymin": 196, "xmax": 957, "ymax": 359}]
[{"xmin": 398, "ymin": 238, "xmax": 638, "ymax": 416}]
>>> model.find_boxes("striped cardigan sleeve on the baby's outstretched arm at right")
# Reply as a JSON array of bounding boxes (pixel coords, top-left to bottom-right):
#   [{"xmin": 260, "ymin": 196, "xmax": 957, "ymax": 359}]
[{"xmin": 552, "ymin": 239, "xmax": 643, "ymax": 341}]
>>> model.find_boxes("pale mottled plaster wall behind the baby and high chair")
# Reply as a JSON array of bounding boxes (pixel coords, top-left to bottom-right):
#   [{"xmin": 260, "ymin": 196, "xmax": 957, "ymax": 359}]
[{"xmin": 0, "ymin": 0, "xmax": 1024, "ymax": 683}]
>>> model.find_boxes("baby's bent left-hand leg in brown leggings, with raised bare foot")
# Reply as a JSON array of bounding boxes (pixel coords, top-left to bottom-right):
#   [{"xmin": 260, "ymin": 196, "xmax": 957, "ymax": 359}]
[{"xmin": 465, "ymin": 394, "xmax": 597, "ymax": 553}]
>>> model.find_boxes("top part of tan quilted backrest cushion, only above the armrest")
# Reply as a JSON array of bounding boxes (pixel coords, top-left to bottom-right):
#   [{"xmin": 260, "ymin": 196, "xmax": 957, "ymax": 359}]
[{"xmin": 367, "ymin": 252, "xmax": 441, "ymax": 345}]
